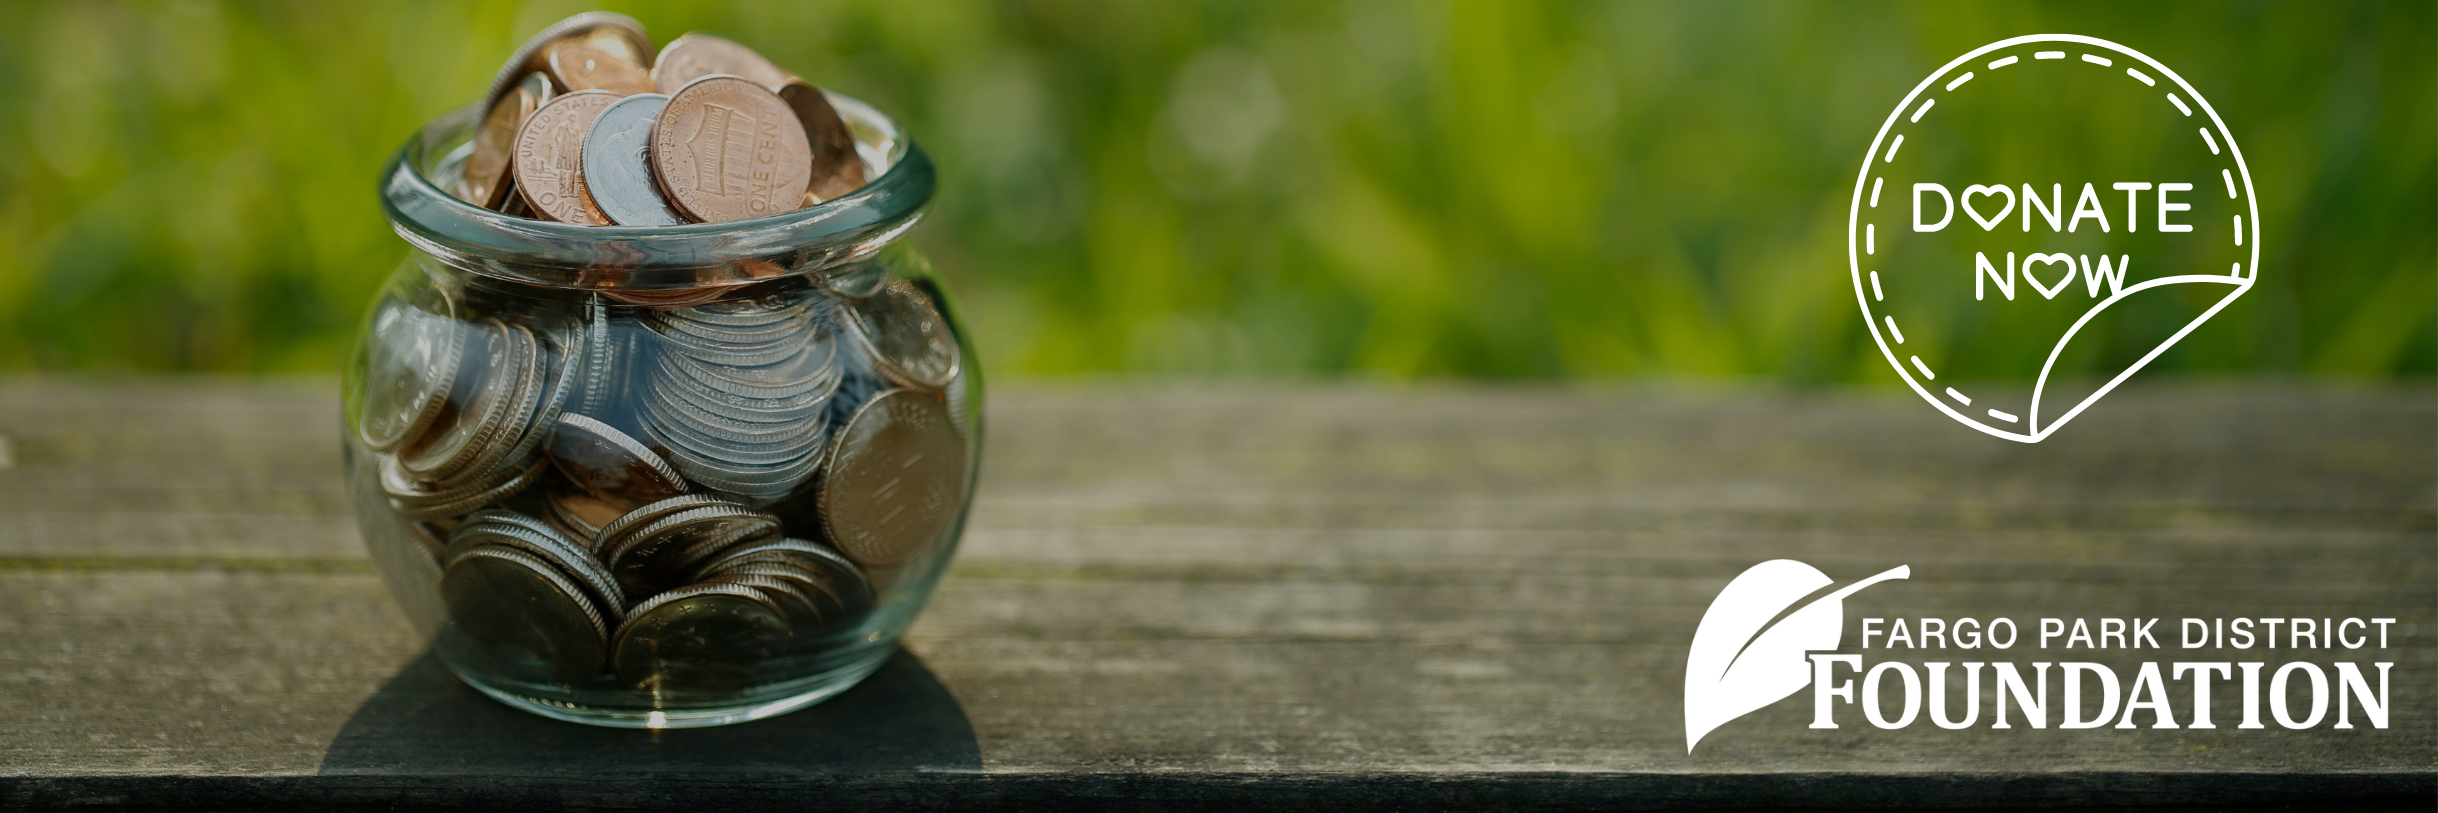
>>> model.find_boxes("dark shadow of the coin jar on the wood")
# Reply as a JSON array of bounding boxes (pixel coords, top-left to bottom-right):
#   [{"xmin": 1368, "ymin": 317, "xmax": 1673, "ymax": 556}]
[{"xmin": 322, "ymin": 649, "xmax": 983, "ymax": 776}]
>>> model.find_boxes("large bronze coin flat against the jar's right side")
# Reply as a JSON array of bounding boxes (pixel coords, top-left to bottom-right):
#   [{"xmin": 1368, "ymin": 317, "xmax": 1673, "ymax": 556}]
[{"xmin": 817, "ymin": 391, "xmax": 965, "ymax": 566}]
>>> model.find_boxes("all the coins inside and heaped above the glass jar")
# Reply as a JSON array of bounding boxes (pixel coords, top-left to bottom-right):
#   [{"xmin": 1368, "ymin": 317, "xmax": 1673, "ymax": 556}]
[{"xmin": 351, "ymin": 12, "xmax": 970, "ymax": 693}]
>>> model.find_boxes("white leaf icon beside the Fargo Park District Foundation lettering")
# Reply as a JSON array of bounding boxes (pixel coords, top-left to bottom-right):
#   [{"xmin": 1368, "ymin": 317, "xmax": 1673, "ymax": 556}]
[{"xmin": 1685, "ymin": 559, "xmax": 1911, "ymax": 754}]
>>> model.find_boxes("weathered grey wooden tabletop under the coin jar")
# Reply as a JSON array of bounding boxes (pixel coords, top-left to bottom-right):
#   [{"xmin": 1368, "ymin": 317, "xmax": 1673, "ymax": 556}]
[{"xmin": 0, "ymin": 378, "xmax": 2438, "ymax": 811}]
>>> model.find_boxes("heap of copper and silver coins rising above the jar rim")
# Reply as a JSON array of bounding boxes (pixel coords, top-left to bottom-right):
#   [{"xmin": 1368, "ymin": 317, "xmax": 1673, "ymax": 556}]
[{"xmin": 456, "ymin": 12, "xmax": 868, "ymax": 227}]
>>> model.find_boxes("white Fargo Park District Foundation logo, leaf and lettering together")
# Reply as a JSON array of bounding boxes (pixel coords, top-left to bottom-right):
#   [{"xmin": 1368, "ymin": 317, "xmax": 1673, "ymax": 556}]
[{"xmin": 1685, "ymin": 559, "xmax": 2414, "ymax": 754}]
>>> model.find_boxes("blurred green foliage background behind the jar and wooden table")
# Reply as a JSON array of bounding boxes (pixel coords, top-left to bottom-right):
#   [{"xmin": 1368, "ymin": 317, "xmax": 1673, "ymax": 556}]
[{"xmin": 0, "ymin": 0, "xmax": 2438, "ymax": 378}]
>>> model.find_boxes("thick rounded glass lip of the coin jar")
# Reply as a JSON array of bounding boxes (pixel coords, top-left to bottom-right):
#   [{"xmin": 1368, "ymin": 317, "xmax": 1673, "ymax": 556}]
[{"xmin": 380, "ymin": 90, "xmax": 936, "ymax": 291}]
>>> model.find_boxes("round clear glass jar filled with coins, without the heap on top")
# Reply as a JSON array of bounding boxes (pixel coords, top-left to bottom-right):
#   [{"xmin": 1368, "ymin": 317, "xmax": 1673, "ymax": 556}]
[{"xmin": 344, "ymin": 95, "xmax": 983, "ymax": 728}]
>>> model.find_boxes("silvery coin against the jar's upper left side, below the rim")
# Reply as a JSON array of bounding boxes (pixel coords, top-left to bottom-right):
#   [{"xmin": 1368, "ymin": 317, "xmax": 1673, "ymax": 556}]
[{"xmin": 356, "ymin": 295, "xmax": 466, "ymax": 452}]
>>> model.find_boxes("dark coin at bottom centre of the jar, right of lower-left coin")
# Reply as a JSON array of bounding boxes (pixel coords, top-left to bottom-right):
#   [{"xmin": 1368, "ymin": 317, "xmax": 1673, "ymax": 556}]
[{"xmin": 610, "ymin": 584, "xmax": 792, "ymax": 691}]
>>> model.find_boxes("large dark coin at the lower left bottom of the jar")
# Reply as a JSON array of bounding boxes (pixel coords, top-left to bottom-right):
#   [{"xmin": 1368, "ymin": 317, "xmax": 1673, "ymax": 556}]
[{"xmin": 441, "ymin": 544, "xmax": 610, "ymax": 684}]
